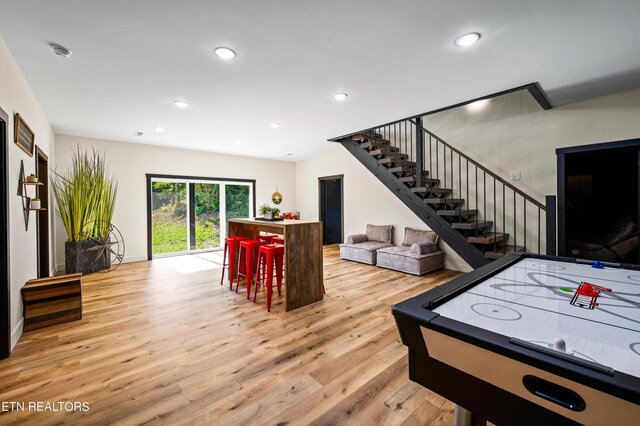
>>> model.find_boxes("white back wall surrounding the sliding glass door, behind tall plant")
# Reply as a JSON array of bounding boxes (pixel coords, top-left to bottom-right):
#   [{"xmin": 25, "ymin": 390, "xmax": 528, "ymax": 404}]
[{"xmin": 56, "ymin": 135, "xmax": 296, "ymax": 270}]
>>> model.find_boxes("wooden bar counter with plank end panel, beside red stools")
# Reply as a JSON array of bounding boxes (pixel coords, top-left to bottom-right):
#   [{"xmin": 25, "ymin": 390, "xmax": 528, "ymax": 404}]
[{"xmin": 228, "ymin": 219, "xmax": 324, "ymax": 311}]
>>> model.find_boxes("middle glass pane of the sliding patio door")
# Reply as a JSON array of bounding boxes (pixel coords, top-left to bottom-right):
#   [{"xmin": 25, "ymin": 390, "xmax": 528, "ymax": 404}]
[{"xmin": 194, "ymin": 183, "xmax": 220, "ymax": 250}]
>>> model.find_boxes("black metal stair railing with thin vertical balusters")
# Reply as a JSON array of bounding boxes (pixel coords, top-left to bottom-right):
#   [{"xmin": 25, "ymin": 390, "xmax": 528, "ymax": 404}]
[{"xmin": 332, "ymin": 117, "xmax": 546, "ymax": 253}]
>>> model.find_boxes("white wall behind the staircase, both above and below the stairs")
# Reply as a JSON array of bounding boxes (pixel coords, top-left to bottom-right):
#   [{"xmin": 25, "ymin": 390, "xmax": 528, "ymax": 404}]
[{"xmin": 296, "ymin": 89, "xmax": 640, "ymax": 271}]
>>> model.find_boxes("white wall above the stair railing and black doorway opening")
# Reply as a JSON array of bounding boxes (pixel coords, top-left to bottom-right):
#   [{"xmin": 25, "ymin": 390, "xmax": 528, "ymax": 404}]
[{"xmin": 424, "ymin": 89, "xmax": 640, "ymax": 202}]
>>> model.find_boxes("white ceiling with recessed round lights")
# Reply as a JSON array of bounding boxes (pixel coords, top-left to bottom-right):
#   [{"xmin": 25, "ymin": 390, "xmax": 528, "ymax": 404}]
[{"xmin": 0, "ymin": 0, "xmax": 640, "ymax": 160}]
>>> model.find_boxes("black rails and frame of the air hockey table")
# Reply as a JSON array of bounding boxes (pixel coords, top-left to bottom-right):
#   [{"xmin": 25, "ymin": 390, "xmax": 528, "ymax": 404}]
[{"xmin": 392, "ymin": 254, "xmax": 640, "ymax": 425}]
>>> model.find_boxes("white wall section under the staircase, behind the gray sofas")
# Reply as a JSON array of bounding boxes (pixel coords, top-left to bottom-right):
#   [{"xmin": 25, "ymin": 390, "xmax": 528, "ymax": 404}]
[{"xmin": 296, "ymin": 142, "xmax": 471, "ymax": 271}]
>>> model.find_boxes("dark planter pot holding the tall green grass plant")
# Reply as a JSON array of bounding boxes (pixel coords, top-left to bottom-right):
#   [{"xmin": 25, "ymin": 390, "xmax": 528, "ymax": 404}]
[{"xmin": 64, "ymin": 238, "xmax": 111, "ymax": 275}]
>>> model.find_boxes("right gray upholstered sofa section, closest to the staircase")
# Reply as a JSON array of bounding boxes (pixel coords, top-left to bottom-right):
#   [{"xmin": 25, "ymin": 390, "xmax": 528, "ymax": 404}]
[{"xmin": 376, "ymin": 228, "xmax": 444, "ymax": 275}]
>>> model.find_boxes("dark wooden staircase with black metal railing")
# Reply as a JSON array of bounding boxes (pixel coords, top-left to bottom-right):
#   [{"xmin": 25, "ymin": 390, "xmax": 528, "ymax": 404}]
[{"xmin": 331, "ymin": 117, "xmax": 546, "ymax": 268}]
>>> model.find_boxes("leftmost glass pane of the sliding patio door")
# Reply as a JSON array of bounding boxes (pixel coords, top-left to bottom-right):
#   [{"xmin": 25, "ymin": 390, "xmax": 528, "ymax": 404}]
[{"xmin": 151, "ymin": 182, "xmax": 188, "ymax": 254}]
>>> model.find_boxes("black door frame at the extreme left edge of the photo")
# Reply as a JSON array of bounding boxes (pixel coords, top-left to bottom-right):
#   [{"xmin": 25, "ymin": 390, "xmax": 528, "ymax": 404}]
[{"xmin": 0, "ymin": 108, "xmax": 11, "ymax": 359}]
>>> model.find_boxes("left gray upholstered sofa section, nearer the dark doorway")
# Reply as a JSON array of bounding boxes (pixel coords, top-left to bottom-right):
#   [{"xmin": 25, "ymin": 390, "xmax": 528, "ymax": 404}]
[{"xmin": 340, "ymin": 225, "xmax": 393, "ymax": 265}]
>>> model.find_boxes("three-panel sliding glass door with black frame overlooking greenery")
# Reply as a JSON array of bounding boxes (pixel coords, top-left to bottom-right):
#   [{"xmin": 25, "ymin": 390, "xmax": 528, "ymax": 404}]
[{"xmin": 147, "ymin": 175, "xmax": 254, "ymax": 258}]
